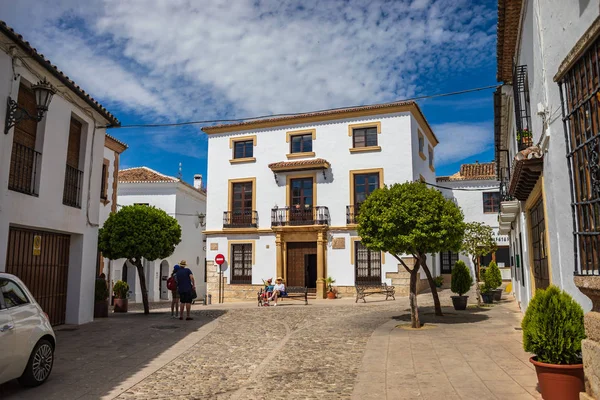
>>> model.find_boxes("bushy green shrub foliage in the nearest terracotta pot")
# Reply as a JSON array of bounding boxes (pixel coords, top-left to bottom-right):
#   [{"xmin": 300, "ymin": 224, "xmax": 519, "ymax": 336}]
[{"xmin": 521, "ymin": 286, "xmax": 585, "ymax": 364}]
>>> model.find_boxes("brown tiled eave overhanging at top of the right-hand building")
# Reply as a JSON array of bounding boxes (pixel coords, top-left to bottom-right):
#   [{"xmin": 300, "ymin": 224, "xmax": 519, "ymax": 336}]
[{"xmin": 496, "ymin": 0, "xmax": 523, "ymax": 83}]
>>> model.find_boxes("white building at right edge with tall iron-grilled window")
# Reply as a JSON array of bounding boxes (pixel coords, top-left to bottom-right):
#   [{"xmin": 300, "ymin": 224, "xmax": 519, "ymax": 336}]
[{"xmin": 494, "ymin": 0, "xmax": 600, "ymax": 311}]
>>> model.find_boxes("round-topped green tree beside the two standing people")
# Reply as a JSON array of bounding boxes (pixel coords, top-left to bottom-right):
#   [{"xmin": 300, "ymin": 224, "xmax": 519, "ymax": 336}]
[{"xmin": 98, "ymin": 205, "xmax": 181, "ymax": 314}]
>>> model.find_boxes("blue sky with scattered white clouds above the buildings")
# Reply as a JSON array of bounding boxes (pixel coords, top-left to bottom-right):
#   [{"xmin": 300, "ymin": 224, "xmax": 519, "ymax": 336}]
[{"xmin": 0, "ymin": 0, "xmax": 497, "ymax": 182}]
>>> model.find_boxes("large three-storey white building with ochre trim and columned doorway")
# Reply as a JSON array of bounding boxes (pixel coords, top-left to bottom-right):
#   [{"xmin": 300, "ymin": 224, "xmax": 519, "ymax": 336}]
[{"xmin": 203, "ymin": 102, "xmax": 438, "ymax": 301}]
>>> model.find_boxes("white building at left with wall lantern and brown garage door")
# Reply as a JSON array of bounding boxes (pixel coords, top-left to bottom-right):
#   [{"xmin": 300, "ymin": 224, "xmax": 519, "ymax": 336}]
[{"xmin": 0, "ymin": 23, "xmax": 119, "ymax": 325}]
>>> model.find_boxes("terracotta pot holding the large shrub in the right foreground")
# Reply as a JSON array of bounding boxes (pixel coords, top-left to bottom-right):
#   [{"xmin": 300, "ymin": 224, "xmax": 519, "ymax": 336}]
[{"xmin": 529, "ymin": 357, "xmax": 585, "ymax": 400}]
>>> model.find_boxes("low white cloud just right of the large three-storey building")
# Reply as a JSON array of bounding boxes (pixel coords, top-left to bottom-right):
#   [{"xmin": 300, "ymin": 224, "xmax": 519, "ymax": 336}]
[{"xmin": 432, "ymin": 121, "xmax": 494, "ymax": 165}]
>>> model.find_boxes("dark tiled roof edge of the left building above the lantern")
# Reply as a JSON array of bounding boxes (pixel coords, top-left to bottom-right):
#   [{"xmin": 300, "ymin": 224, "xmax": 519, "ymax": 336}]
[{"xmin": 0, "ymin": 21, "xmax": 121, "ymax": 126}]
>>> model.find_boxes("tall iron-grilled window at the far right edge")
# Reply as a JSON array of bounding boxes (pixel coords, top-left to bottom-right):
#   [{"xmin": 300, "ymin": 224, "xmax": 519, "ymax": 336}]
[{"xmin": 559, "ymin": 39, "xmax": 600, "ymax": 275}]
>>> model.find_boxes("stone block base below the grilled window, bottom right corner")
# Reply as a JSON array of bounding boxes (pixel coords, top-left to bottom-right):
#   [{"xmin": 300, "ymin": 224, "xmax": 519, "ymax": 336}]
[{"xmin": 574, "ymin": 276, "xmax": 600, "ymax": 400}]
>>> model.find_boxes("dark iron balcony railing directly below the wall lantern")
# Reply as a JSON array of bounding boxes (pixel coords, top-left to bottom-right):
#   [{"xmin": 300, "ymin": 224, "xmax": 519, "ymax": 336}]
[{"xmin": 8, "ymin": 142, "xmax": 42, "ymax": 196}]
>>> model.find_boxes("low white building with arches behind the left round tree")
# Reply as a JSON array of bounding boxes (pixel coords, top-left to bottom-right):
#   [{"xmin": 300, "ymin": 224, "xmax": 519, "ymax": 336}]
[{"xmin": 104, "ymin": 167, "xmax": 211, "ymax": 302}]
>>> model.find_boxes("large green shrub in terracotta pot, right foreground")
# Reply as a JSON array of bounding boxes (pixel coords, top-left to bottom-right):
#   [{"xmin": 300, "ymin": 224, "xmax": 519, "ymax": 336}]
[{"xmin": 521, "ymin": 286, "xmax": 585, "ymax": 400}]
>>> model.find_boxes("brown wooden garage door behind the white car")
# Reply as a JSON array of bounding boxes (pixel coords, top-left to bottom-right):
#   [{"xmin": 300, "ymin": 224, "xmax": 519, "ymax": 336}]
[{"xmin": 6, "ymin": 227, "xmax": 70, "ymax": 325}]
